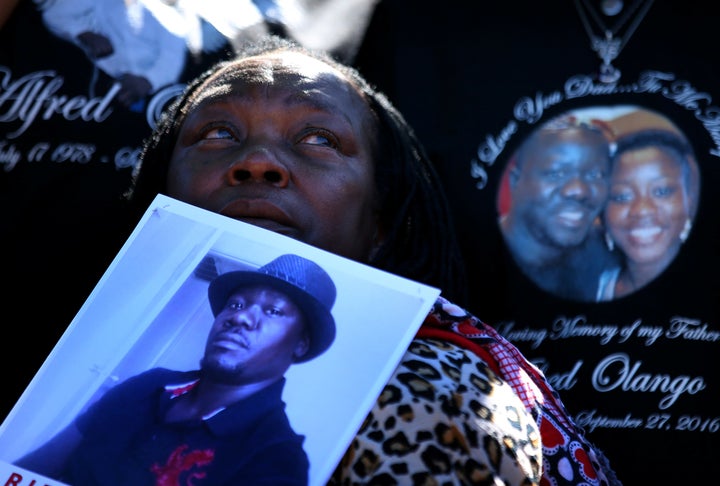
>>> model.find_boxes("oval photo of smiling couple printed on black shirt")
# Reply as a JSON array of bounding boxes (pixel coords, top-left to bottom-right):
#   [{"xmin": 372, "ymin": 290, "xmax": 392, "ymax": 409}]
[{"xmin": 498, "ymin": 105, "xmax": 700, "ymax": 302}]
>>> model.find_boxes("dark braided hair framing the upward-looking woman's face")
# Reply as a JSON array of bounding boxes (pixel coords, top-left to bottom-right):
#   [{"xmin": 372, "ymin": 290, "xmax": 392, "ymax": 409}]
[{"xmin": 126, "ymin": 36, "xmax": 466, "ymax": 305}]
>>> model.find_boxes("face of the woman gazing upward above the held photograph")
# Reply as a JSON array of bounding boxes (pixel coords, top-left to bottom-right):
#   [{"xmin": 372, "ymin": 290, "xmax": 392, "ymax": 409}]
[{"xmin": 167, "ymin": 52, "xmax": 376, "ymax": 261}]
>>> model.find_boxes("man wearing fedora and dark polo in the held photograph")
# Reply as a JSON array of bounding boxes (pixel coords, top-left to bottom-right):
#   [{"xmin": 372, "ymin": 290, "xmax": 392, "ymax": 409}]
[{"xmin": 15, "ymin": 254, "xmax": 336, "ymax": 486}]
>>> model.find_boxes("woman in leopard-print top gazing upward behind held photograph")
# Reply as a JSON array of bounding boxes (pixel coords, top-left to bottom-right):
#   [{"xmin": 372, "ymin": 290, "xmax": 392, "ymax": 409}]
[{"xmin": 130, "ymin": 38, "xmax": 614, "ymax": 485}]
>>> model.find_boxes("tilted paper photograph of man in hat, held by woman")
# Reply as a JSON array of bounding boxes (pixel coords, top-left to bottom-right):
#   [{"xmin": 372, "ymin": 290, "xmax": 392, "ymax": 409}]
[{"xmin": 0, "ymin": 196, "xmax": 439, "ymax": 485}]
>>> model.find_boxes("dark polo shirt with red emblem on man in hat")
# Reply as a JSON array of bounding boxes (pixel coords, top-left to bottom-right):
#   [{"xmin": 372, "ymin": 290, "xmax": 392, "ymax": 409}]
[{"xmin": 64, "ymin": 368, "xmax": 309, "ymax": 486}]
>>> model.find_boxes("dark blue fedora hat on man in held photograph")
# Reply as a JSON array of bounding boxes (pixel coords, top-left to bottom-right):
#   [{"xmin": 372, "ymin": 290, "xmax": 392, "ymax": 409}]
[{"xmin": 208, "ymin": 254, "xmax": 337, "ymax": 363}]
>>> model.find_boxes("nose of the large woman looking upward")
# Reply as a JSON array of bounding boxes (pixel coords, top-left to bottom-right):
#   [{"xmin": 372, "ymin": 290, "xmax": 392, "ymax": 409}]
[{"xmin": 226, "ymin": 147, "xmax": 290, "ymax": 187}]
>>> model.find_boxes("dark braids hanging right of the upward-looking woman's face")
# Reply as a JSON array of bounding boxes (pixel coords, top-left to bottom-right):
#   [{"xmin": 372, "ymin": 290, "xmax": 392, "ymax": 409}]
[{"xmin": 360, "ymin": 93, "xmax": 466, "ymax": 303}]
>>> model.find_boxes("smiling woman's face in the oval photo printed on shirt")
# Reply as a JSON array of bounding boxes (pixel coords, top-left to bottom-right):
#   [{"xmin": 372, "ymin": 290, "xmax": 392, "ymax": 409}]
[{"xmin": 605, "ymin": 147, "xmax": 689, "ymax": 268}]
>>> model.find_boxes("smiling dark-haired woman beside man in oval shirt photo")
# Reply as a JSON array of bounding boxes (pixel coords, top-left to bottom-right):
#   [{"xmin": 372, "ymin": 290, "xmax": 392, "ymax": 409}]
[{"xmin": 598, "ymin": 129, "xmax": 698, "ymax": 301}]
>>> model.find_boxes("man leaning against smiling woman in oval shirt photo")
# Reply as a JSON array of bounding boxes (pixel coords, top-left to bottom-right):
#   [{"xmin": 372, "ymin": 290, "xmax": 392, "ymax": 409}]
[{"xmin": 500, "ymin": 115, "xmax": 612, "ymax": 302}]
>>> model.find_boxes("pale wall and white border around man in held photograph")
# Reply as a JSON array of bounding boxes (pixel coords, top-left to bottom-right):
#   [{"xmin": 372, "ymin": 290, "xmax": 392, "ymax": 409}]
[{"xmin": 0, "ymin": 195, "xmax": 440, "ymax": 486}]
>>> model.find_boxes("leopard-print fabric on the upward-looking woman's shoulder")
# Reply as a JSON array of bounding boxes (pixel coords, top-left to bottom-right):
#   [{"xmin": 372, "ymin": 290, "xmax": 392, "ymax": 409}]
[{"xmin": 328, "ymin": 338, "xmax": 542, "ymax": 486}]
